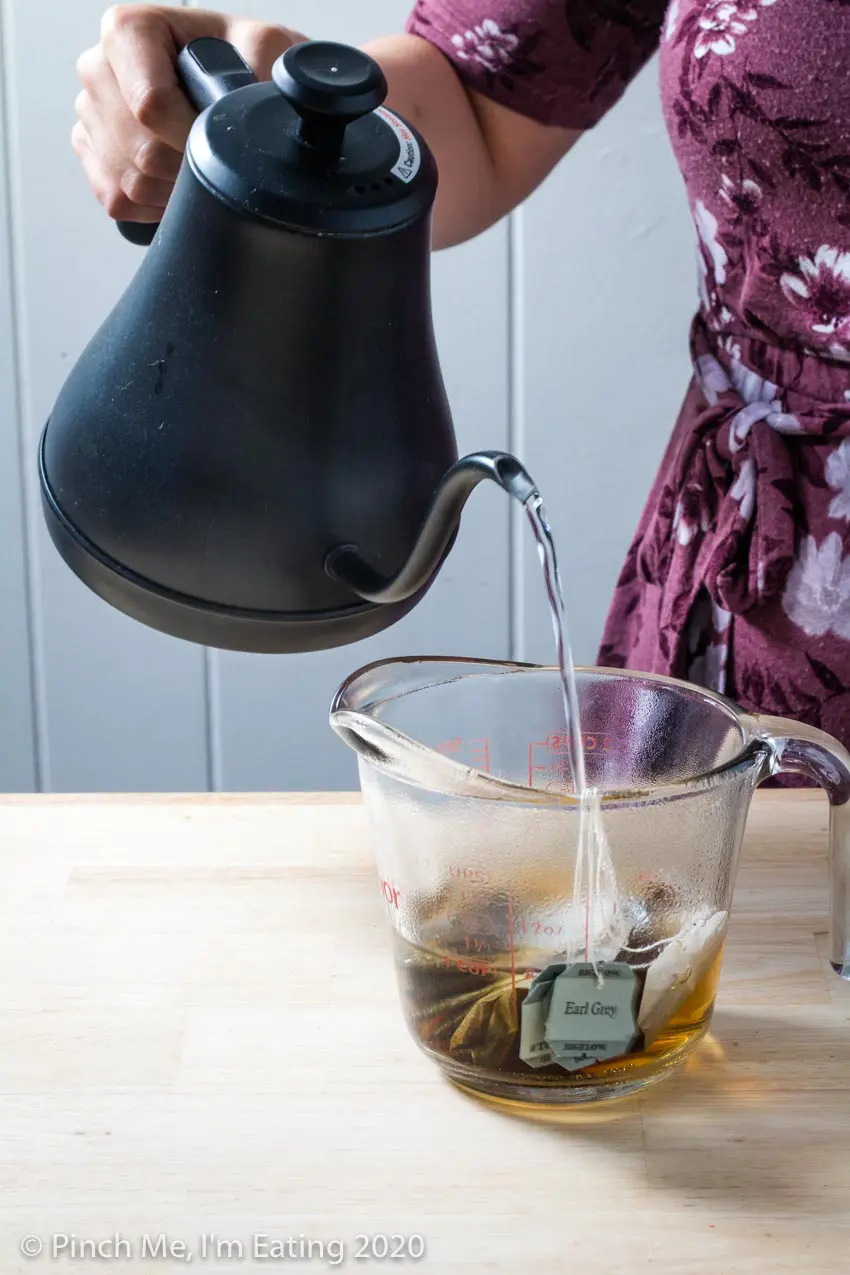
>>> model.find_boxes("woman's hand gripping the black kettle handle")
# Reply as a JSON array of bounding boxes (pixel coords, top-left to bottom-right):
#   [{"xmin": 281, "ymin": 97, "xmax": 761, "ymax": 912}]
[{"xmin": 71, "ymin": 4, "xmax": 305, "ymax": 222}]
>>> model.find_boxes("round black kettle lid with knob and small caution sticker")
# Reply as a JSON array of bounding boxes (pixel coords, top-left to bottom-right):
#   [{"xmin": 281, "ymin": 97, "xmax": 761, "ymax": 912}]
[{"xmin": 186, "ymin": 41, "xmax": 437, "ymax": 235}]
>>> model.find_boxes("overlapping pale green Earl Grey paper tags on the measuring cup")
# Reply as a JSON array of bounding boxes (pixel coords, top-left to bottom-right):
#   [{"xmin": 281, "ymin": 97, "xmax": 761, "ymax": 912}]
[{"xmin": 520, "ymin": 961, "xmax": 640, "ymax": 1071}]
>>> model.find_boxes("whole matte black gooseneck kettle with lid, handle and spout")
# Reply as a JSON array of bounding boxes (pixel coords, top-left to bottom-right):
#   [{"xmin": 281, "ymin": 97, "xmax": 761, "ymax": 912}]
[{"xmin": 40, "ymin": 40, "xmax": 533, "ymax": 652}]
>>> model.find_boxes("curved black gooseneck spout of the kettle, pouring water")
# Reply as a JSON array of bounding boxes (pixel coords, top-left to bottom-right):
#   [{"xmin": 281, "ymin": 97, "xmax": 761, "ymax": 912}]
[{"xmin": 325, "ymin": 451, "xmax": 537, "ymax": 603}]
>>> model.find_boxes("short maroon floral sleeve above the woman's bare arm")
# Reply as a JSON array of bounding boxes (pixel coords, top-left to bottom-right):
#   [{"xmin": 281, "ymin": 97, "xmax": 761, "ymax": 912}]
[{"xmin": 407, "ymin": 0, "xmax": 666, "ymax": 129}]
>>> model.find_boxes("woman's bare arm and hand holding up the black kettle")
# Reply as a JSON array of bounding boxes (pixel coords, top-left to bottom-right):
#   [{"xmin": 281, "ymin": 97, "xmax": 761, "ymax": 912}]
[{"xmin": 73, "ymin": 5, "xmax": 580, "ymax": 247}]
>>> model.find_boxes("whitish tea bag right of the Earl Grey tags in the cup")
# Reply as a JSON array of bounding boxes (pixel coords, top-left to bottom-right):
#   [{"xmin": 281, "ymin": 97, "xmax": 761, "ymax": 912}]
[{"xmin": 637, "ymin": 909, "xmax": 728, "ymax": 1047}]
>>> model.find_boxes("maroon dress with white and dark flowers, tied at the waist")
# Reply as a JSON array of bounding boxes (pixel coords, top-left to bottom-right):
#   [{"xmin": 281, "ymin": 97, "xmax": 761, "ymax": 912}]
[{"xmin": 408, "ymin": 0, "xmax": 850, "ymax": 745}]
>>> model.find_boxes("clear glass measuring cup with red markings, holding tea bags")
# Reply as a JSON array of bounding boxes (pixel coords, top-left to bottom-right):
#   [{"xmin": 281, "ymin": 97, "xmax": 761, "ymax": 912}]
[{"xmin": 331, "ymin": 658, "xmax": 850, "ymax": 1103}]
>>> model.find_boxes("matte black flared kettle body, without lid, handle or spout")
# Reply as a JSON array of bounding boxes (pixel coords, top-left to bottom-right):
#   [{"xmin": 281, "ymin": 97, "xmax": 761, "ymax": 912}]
[{"xmin": 41, "ymin": 145, "xmax": 457, "ymax": 652}]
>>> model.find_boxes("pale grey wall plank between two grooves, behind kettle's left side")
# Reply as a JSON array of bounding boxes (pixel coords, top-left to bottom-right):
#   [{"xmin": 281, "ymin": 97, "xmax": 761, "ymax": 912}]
[{"xmin": 4, "ymin": 0, "xmax": 210, "ymax": 792}]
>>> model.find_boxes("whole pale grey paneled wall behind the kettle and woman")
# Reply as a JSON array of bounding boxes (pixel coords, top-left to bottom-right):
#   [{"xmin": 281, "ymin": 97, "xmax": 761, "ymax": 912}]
[{"xmin": 0, "ymin": 0, "xmax": 693, "ymax": 792}]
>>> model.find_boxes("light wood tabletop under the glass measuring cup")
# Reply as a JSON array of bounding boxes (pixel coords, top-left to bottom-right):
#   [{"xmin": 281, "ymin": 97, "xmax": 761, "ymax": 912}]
[{"xmin": 0, "ymin": 793, "xmax": 850, "ymax": 1275}]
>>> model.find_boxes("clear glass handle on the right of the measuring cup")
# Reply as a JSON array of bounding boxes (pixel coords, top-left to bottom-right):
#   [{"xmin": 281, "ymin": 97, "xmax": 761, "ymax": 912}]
[{"xmin": 747, "ymin": 717, "xmax": 850, "ymax": 979}]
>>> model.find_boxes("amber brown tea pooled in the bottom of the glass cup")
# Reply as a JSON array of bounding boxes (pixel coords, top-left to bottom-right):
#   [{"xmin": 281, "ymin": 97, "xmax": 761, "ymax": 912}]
[{"xmin": 394, "ymin": 933, "xmax": 723, "ymax": 1100}]
